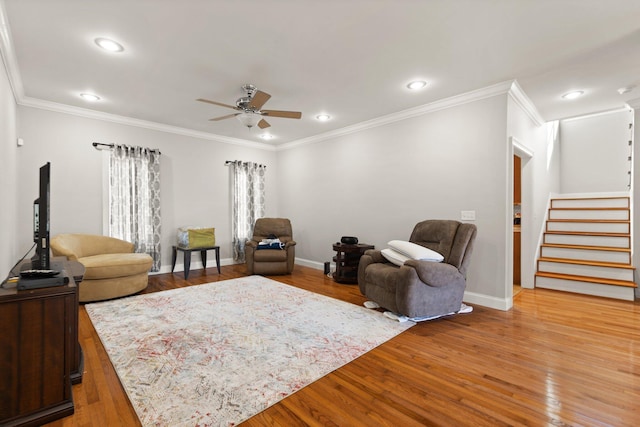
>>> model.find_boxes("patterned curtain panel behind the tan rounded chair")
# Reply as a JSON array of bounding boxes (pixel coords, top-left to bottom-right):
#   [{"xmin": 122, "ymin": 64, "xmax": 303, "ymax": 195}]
[{"xmin": 109, "ymin": 145, "xmax": 161, "ymax": 271}]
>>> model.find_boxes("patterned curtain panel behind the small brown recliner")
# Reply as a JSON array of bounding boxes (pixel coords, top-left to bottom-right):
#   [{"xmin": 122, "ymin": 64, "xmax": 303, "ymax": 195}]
[{"xmin": 231, "ymin": 161, "xmax": 266, "ymax": 262}]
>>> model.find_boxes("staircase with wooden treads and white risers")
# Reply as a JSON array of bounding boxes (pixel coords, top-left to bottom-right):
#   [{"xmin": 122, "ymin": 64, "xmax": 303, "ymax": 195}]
[{"xmin": 535, "ymin": 197, "xmax": 636, "ymax": 301}]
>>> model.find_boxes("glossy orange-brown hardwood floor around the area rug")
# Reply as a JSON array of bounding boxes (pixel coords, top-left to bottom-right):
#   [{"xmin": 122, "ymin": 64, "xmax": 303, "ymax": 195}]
[{"xmin": 48, "ymin": 266, "xmax": 640, "ymax": 427}]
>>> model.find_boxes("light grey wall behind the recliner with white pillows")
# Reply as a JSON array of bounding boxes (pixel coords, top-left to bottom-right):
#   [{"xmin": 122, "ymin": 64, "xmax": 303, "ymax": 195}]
[{"xmin": 278, "ymin": 94, "xmax": 508, "ymax": 306}]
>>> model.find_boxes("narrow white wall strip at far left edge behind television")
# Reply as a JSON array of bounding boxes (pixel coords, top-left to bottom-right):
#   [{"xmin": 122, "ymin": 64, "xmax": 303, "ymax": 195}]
[{"xmin": 0, "ymin": 54, "xmax": 18, "ymax": 281}]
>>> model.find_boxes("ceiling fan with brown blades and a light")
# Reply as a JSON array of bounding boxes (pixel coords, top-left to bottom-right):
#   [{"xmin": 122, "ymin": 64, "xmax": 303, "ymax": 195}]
[{"xmin": 197, "ymin": 84, "xmax": 302, "ymax": 129}]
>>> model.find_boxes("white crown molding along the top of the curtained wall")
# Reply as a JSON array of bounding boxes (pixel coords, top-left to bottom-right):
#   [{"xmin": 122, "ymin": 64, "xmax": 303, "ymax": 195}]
[{"xmin": 18, "ymin": 97, "xmax": 275, "ymax": 151}]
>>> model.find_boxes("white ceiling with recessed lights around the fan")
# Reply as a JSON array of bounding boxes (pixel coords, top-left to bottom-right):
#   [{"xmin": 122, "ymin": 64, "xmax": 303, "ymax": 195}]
[{"xmin": 0, "ymin": 0, "xmax": 640, "ymax": 145}]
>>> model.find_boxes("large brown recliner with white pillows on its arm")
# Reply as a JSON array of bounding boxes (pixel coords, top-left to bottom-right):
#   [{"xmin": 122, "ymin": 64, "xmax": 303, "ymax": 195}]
[{"xmin": 358, "ymin": 220, "xmax": 476, "ymax": 318}]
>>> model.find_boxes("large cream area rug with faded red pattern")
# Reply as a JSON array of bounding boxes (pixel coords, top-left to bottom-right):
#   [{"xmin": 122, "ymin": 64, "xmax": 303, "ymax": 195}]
[{"xmin": 85, "ymin": 276, "xmax": 414, "ymax": 426}]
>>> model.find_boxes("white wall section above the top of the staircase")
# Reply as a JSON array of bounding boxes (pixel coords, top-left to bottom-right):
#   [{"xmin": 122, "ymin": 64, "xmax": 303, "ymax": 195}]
[{"xmin": 560, "ymin": 110, "xmax": 633, "ymax": 193}]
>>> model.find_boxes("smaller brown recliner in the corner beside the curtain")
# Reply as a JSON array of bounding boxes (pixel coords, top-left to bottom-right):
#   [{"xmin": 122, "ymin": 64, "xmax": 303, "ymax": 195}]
[{"xmin": 244, "ymin": 218, "xmax": 296, "ymax": 275}]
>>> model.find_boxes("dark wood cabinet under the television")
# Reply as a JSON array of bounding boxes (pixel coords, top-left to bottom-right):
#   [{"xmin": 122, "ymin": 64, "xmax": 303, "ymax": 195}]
[{"xmin": 0, "ymin": 260, "xmax": 82, "ymax": 426}]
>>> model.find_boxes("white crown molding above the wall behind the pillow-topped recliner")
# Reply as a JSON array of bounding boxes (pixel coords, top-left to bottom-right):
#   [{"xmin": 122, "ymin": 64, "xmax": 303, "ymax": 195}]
[{"xmin": 276, "ymin": 81, "xmax": 516, "ymax": 151}]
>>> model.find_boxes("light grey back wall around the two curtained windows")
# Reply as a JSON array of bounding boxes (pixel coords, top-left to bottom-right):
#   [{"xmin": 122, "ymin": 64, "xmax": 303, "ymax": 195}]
[{"xmin": 14, "ymin": 106, "xmax": 278, "ymax": 271}]
